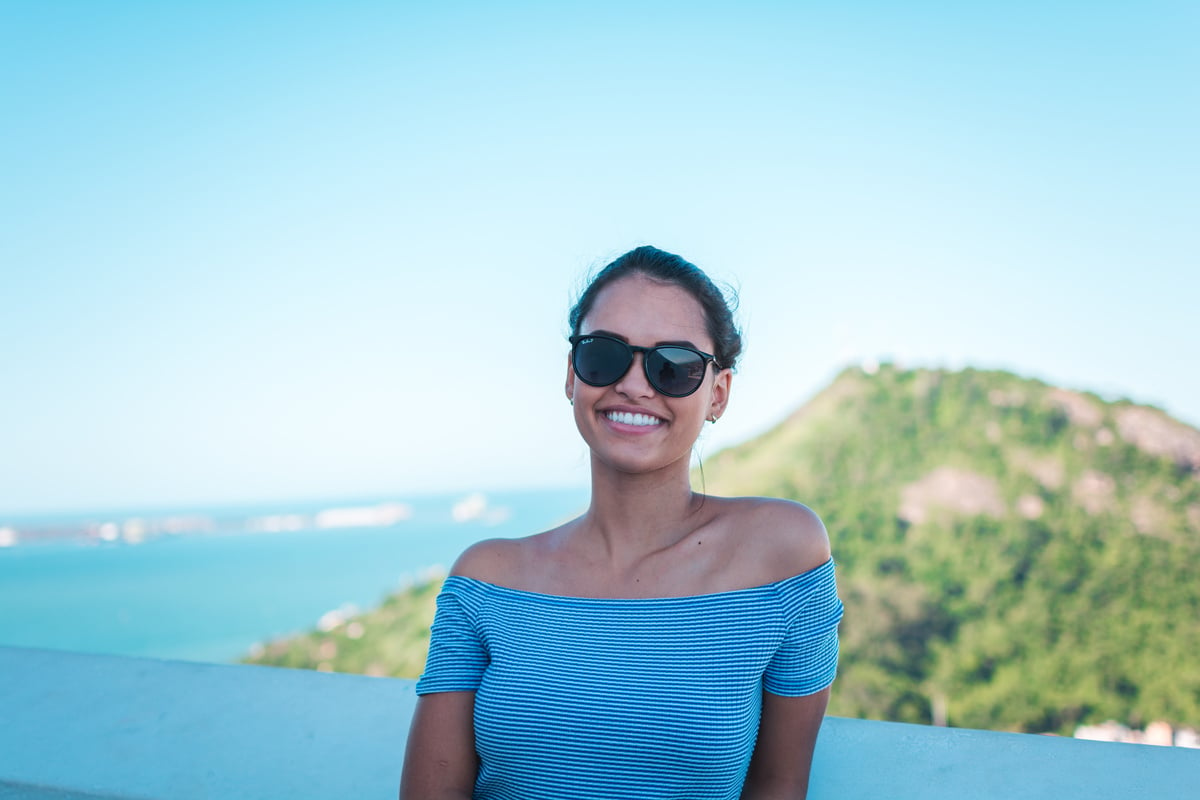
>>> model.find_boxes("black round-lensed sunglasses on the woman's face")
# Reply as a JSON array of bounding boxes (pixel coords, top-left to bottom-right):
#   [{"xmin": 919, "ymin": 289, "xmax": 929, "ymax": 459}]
[{"xmin": 570, "ymin": 333, "xmax": 720, "ymax": 397}]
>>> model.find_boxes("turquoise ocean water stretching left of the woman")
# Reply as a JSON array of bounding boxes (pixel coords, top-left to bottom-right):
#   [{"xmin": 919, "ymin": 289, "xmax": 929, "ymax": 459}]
[{"xmin": 0, "ymin": 489, "xmax": 587, "ymax": 662}]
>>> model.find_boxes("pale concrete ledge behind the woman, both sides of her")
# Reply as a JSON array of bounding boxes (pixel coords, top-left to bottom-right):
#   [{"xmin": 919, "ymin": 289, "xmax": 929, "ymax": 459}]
[{"xmin": 0, "ymin": 648, "xmax": 1200, "ymax": 800}]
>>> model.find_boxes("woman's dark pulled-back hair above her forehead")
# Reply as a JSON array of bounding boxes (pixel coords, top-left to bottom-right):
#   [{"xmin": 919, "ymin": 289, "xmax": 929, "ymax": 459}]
[{"xmin": 568, "ymin": 245, "xmax": 742, "ymax": 369}]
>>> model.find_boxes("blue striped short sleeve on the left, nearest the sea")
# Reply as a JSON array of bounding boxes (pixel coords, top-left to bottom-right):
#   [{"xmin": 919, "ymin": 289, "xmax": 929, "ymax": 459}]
[{"xmin": 416, "ymin": 577, "xmax": 488, "ymax": 694}]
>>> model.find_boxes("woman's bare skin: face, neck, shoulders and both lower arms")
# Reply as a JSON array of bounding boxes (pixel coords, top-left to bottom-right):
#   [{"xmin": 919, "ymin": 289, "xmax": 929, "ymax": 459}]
[{"xmin": 401, "ymin": 275, "xmax": 829, "ymax": 800}]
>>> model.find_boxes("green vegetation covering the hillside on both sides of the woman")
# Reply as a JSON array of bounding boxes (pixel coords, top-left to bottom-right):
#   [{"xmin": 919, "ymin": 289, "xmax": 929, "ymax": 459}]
[{"xmin": 246, "ymin": 366, "xmax": 1200, "ymax": 733}]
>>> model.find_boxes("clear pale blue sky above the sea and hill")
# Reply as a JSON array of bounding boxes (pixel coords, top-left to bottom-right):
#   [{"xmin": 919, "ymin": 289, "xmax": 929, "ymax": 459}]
[{"xmin": 0, "ymin": 1, "xmax": 1200, "ymax": 512}]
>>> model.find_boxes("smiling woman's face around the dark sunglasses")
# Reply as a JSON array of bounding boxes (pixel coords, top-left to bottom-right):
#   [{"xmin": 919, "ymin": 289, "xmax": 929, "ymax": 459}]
[{"xmin": 566, "ymin": 275, "xmax": 731, "ymax": 473}]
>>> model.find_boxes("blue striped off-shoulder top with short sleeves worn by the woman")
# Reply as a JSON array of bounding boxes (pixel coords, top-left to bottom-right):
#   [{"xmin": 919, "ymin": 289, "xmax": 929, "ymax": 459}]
[{"xmin": 416, "ymin": 560, "xmax": 842, "ymax": 800}]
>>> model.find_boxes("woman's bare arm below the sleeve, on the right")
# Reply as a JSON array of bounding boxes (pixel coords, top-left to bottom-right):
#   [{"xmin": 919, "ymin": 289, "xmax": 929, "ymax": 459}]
[{"xmin": 742, "ymin": 688, "xmax": 829, "ymax": 800}]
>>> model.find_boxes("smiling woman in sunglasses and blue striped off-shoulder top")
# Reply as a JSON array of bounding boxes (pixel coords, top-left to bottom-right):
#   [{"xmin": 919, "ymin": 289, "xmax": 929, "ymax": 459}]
[{"xmin": 400, "ymin": 247, "xmax": 841, "ymax": 800}]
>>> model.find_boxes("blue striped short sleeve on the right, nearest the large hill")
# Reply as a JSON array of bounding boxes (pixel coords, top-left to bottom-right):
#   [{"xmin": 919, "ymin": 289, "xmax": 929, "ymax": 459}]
[{"xmin": 763, "ymin": 560, "xmax": 842, "ymax": 697}]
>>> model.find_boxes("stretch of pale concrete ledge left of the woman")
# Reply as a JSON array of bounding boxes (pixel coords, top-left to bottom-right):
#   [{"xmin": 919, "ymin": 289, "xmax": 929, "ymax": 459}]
[{"xmin": 0, "ymin": 649, "xmax": 416, "ymax": 800}]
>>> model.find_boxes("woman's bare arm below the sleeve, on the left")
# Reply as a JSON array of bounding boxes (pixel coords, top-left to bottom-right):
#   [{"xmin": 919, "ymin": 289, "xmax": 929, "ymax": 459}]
[{"xmin": 400, "ymin": 692, "xmax": 479, "ymax": 800}]
